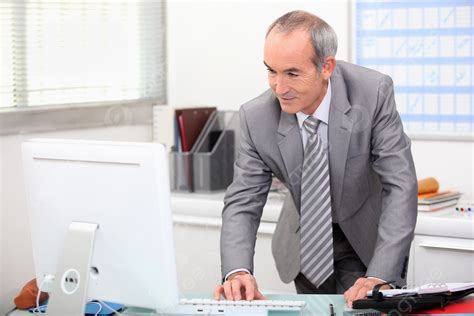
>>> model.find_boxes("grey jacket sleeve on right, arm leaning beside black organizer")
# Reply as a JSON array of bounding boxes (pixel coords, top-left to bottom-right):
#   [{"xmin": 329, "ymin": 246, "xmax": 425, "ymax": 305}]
[{"xmin": 367, "ymin": 76, "xmax": 418, "ymax": 285}]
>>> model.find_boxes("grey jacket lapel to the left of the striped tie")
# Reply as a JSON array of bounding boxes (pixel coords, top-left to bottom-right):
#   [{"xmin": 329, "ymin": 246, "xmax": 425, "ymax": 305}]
[{"xmin": 277, "ymin": 111, "xmax": 303, "ymax": 210}]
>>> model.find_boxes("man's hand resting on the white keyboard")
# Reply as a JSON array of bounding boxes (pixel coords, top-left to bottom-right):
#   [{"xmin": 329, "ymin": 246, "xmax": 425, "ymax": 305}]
[{"xmin": 214, "ymin": 271, "xmax": 266, "ymax": 301}]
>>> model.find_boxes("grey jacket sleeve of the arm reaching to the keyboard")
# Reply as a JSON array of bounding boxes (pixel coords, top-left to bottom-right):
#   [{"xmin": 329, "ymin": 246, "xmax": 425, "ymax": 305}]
[{"xmin": 220, "ymin": 107, "xmax": 272, "ymax": 277}]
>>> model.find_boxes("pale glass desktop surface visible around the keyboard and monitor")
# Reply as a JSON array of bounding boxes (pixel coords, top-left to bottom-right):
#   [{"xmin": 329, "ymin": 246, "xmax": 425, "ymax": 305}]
[{"xmin": 8, "ymin": 294, "xmax": 368, "ymax": 316}]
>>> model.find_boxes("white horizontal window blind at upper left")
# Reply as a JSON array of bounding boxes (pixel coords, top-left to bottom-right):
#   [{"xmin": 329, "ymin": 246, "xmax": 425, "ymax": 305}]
[{"xmin": 0, "ymin": 0, "xmax": 166, "ymax": 107}]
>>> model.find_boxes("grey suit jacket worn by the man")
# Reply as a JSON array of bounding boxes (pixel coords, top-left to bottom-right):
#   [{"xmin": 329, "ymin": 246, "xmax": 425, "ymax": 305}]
[{"xmin": 221, "ymin": 62, "xmax": 417, "ymax": 285}]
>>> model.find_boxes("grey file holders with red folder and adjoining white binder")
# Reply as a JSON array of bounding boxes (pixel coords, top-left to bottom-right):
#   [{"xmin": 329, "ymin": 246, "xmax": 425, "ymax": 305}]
[{"xmin": 153, "ymin": 106, "xmax": 239, "ymax": 192}]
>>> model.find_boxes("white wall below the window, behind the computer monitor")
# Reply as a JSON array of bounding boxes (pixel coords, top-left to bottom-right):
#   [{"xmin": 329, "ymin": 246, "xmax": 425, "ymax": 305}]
[{"xmin": 0, "ymin": 126, "xmax": 152, "ymax": 308}]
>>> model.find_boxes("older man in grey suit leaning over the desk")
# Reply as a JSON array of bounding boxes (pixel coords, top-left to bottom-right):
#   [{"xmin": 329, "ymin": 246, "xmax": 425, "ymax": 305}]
[{"xmin": 215, "ymin": 11, "xmax": 417, "ymax": 305}]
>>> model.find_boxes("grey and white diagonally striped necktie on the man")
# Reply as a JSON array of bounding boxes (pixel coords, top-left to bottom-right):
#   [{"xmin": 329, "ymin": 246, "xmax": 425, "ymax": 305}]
[{"xmin": 300, "ymin": 116, "xmax": 333, "ymax": 287}]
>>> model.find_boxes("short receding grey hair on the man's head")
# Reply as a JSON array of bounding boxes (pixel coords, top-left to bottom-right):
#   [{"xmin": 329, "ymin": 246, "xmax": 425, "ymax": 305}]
[{"xmin": 265, "ymin": 10, "xmax": 337, "ymax": 71}]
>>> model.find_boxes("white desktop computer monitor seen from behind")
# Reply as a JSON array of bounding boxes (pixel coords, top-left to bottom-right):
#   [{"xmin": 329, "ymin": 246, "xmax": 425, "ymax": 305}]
[{"xmin": 22, "ymin": 139, "xmax": 178, "ymax": 315}]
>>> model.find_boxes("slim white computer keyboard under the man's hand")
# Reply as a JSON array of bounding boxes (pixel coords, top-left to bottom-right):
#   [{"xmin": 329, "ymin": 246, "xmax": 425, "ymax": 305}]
[{"xmin": 172, "ymin": 298, "xmax": 306, "ymax": 315}]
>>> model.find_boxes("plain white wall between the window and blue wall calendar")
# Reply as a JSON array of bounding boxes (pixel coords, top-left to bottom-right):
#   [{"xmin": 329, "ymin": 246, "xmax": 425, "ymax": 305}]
[{"xmin": 166, "ymin": 0, "xmax": 349, "ymax": 109}]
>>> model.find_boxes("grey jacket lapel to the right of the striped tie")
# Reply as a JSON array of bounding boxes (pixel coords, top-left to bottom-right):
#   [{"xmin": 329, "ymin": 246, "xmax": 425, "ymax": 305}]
[{"xmin": 328, "ymin": 68, "xmax": 352, "ymax": 210}]
